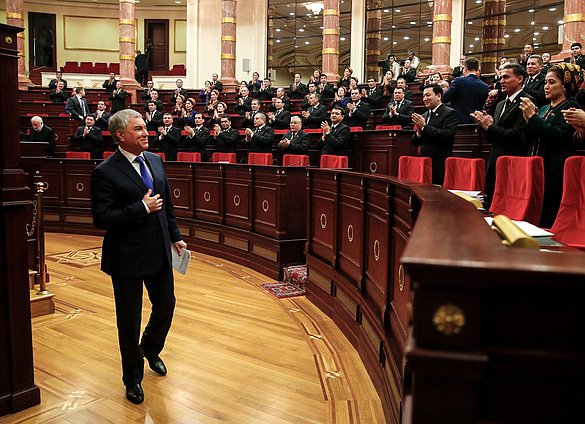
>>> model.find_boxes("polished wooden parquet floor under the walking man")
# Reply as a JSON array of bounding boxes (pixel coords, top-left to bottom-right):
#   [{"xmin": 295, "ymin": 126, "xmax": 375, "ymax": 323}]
[{"xmin": 5, "ymin": 234, "xmax": 385, "ymax": 424}]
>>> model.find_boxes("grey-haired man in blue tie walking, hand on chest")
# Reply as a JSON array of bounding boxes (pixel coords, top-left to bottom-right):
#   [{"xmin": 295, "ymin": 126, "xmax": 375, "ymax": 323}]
[{"xmin": 91, "ymin": 109, "xmax": 187, "ymax": 404}]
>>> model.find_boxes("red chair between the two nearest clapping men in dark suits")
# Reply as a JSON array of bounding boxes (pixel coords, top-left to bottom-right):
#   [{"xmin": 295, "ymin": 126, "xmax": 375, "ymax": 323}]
[{"xmin": 443, "ymin": 158, "xmax": 485, "ymax": 193}]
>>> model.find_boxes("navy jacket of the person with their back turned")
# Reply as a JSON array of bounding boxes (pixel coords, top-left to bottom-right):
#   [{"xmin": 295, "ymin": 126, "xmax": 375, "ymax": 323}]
[{"xmin": 442, "ymin": 74, "xmax": 489, "ymax": 124}]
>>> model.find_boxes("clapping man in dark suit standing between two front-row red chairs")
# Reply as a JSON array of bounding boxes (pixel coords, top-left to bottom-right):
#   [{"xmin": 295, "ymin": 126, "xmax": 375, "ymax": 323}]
[{"xmin": 412, "ymin": 84, "xmax": 457, "ymax": 185}]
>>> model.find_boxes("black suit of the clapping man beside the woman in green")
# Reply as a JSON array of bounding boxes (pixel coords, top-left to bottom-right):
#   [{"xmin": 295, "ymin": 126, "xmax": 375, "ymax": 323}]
[{"xmin": 485, "ymin": 91, "xmax": 534, "ymax": 202}]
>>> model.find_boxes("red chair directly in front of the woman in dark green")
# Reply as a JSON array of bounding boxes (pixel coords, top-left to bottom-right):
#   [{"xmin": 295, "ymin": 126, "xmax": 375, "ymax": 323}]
[{"xmin": 490, "ymin": 156, "xmax": 544, "ymax": 225}]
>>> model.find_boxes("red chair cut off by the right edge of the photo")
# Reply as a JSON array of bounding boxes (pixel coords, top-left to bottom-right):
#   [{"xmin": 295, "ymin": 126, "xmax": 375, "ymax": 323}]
[{"xmin": 551, "ymin": 156, "xmax": 585, "ymax": 249}]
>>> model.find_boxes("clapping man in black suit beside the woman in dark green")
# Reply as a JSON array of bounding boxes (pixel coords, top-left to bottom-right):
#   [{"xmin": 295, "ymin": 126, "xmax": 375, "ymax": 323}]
[{"xmin": 471, "ymin": 63, "xmax": 533, "ymax": 205}]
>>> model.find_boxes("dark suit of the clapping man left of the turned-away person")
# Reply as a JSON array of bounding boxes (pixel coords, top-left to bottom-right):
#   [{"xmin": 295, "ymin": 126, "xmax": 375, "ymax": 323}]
[{"xmin": 412, "ymin": 105, "xmax": 457, "ymax": 185}]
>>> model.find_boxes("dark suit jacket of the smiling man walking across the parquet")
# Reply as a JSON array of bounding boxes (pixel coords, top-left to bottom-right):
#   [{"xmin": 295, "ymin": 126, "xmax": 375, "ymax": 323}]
[{"xmin": 91, "ymin": 150, "xmax": 182, "ymax": 278}]
